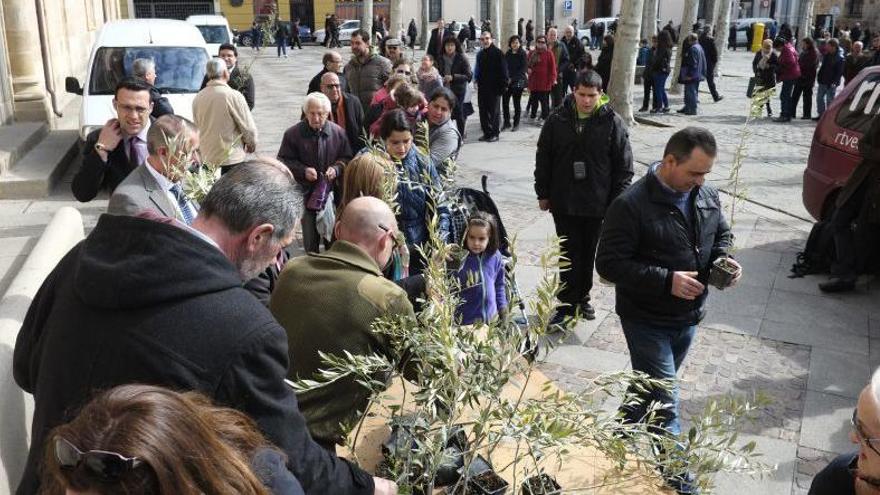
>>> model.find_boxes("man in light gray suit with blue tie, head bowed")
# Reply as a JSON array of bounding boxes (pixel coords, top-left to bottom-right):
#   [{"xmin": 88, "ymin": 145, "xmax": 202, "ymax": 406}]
[{"xmin": 107, "ymin": 115, "xmax": 199, "ymax": 225}]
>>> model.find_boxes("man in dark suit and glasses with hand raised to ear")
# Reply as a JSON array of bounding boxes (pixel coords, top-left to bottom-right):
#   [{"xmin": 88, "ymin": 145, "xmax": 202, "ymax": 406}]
[{"xmin": 71, "ymin": 78, "xmax": 153, "ymax": 203}]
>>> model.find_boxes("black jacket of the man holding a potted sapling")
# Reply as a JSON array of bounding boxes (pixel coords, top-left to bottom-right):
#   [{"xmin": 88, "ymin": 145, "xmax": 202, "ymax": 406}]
[{"xmin": 596, "ymin": 172, "xmax": 733, "ymax": 326}]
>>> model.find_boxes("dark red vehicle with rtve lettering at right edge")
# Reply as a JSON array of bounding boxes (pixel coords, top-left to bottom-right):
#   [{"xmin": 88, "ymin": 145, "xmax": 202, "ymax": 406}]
[{"xmin": 803, "ymin": 67, "xmax": 880, "ymax": 220}]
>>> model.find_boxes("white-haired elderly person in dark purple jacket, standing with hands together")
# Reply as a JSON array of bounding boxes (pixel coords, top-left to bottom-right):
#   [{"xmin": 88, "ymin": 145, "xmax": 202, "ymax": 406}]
[{"xmin": 278, "ymin": 92, "xmax": 352, "ymax": 253}]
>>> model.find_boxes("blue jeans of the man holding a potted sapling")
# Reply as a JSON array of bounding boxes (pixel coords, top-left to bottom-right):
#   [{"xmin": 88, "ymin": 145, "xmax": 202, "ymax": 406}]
[{"xmin": 620, "ymin": 318, "xmax": 697, "ymax": 435}]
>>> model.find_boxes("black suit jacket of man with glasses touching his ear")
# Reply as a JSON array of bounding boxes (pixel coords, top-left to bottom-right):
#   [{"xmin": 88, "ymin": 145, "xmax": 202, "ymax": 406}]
[{"xmin": 70, "ymin": 122, "xmax": 153, "ymax": 203}]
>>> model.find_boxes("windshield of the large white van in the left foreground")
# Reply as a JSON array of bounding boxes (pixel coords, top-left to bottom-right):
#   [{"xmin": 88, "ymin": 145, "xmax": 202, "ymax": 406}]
[{"xmin": 89, "ymin": 46, "xmax": 208, "ymax": 95}]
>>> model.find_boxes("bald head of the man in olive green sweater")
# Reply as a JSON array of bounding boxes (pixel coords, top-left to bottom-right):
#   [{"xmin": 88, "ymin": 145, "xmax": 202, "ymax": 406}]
[{"xmin": 336, "ymin": 196, "xmax": 397, "ymax": 268}]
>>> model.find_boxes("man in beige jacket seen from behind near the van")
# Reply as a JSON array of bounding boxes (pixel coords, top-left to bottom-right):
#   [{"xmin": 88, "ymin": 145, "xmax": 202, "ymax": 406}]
[{"xmin": 193, "ymin": 58, "xmax": 257, "ymax": 174}]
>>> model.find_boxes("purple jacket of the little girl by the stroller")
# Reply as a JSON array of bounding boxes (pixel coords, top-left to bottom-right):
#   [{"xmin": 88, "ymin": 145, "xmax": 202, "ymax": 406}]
[{"xmin": 456, "ymin": 251, "xmax": 507, "ymax": 325}]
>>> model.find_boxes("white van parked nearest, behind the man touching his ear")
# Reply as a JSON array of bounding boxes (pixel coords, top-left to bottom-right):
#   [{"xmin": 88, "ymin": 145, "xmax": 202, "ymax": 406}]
[{"xmin": 65, "ymin": 19, "xmax": 209, "ymax": 140}]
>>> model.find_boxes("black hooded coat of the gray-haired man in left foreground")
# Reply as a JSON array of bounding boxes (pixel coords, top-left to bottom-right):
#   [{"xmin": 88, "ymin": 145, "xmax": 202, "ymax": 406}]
[{"xmin": 13, "ymin": 215, "xmax": 374, "ymax": 495}]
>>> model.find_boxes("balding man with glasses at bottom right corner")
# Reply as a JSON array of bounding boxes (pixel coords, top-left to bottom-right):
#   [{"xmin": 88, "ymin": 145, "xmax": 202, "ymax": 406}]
[{"xmin": 809, "ymin": 369, "xmax": 880, "ymax": 495}]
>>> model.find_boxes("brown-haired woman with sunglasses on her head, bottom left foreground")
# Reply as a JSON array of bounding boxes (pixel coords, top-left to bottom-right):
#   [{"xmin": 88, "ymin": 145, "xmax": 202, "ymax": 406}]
[{"xmin": 42, "ymin": 385, "xmax": 303, "ymax": 495}]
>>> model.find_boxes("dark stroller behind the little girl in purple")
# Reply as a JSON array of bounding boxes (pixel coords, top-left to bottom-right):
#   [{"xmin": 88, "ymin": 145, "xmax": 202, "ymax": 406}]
[{"xmin": 450, "ymin": 175, "xmax": 537, "ymax": 359}]
